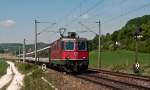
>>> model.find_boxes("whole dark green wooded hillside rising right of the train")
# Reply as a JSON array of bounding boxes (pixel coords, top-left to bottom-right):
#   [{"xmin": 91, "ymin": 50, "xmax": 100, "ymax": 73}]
[{"xmin": 89, "ymin": 15, "xmax": 150, "ymax": 53}]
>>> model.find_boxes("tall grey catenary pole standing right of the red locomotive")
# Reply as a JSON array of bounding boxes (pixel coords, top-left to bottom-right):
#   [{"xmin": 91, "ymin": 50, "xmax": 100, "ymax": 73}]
[{"xmin": 96, "ymin": 20, "xmax": 101, "ymax": 69}]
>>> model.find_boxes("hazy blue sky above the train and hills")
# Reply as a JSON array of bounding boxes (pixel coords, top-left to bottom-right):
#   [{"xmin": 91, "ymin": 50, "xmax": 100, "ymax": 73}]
[{"xmin": 0, "ymin": 0, "xmax": 150, "ymax": 44}]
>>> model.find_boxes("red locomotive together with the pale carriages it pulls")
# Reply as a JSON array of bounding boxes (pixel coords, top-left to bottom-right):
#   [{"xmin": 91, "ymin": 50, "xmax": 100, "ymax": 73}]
[{"xmin": 25, "ymin": 32, "xmax": 89, "ymax": 72}]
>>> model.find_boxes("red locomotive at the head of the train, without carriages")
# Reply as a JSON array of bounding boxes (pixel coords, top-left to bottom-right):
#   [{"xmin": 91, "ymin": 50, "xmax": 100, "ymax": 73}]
[{"xmin": 49, "ymin": 32, "xmax": 89, "ymax": 72}]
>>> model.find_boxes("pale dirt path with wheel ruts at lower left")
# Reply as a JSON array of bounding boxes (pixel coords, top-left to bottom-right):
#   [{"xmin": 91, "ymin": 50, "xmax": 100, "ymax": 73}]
[{"xmin": 0, "ymin": 61, "xmax": 24, "ymax": 90}]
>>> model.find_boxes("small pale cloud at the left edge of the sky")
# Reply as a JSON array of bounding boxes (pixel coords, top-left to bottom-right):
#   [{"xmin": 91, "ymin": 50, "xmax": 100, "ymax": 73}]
[{"xmin": 0, "ymin": 19, "xmax": 16, "ymax": 28}]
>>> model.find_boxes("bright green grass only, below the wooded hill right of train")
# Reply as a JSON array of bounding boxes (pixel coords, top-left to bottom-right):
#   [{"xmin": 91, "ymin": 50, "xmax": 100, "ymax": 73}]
[{"xmin": 89, "ymin": 50, "xmax": 150, "ymax": 66}]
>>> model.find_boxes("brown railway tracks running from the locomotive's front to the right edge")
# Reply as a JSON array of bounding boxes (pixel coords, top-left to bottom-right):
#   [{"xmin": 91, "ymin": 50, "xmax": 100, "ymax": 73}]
[{"xmin": 74, "ymin": 69, "xmax": 150, "ymax": 90}]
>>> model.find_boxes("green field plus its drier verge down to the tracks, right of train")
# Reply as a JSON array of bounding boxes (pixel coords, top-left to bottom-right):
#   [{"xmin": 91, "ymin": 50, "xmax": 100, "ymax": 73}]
[{"xmin": 89, "ymin": 50, "xmax": 150, "ymax": 74}]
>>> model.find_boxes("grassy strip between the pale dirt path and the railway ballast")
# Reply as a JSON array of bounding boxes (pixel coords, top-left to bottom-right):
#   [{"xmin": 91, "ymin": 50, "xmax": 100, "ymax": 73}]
[{"xmin": 16, "ymin": 63, "xmax": 53, "ymax": 90}]
